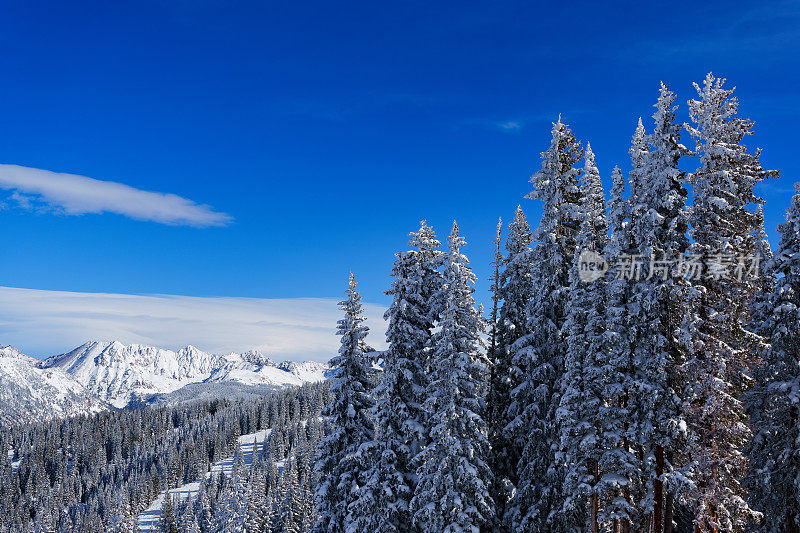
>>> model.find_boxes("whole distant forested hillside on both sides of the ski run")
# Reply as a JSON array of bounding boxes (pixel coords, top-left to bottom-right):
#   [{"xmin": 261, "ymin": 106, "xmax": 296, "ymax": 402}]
[{"xmin": 0, "ymin": 383, "xmax": 329, "ymax": 533}]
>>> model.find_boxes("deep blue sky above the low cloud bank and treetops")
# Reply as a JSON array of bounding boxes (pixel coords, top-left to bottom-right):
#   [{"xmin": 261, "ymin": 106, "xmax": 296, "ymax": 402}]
[{"xmin": 0, "ymin": 0, "xmax": 800, "ymax": 358}]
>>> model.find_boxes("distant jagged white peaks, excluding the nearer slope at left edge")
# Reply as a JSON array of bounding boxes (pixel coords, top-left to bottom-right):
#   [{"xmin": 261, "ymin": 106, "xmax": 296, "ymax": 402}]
[{"xmin": 40, "ymin": 341, "xmax": 328, "ymax": 407}]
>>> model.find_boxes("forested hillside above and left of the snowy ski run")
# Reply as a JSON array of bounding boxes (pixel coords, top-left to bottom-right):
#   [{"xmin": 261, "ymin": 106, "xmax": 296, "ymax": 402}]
[{"xmin": 0, "ymin": 383, "xmax": 328, "ymax": 532}]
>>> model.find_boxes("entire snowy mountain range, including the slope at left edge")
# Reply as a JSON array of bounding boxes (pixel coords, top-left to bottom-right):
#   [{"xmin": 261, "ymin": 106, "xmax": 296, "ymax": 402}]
[{"xmin": 0, "ymin": 341, "xmax": 329, "ymax": 425}]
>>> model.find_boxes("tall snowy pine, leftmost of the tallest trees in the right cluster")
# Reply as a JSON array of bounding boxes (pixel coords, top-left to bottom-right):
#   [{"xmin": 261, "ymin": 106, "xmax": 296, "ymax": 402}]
[{"xmin": 506, "ymin": 117, "xmax": 583, "ymax": 531}]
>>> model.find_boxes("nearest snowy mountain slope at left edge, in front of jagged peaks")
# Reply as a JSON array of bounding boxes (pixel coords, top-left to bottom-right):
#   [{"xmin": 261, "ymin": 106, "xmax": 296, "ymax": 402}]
[{"xmin": 0, "ymin": 346, "xmax": 107, "ymax": 425}]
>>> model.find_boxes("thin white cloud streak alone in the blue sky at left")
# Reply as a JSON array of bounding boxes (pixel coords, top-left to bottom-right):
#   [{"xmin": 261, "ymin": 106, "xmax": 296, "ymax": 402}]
[{"xmin": 0, "ymin": 164, "xmax": 233, "ymax": 228}]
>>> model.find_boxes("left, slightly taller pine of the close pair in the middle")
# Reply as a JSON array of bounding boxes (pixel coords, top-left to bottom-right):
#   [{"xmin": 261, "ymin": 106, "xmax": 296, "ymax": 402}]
[{"xmin": 351, "ymin": 220, "xmax": 442, "ymax": 533}]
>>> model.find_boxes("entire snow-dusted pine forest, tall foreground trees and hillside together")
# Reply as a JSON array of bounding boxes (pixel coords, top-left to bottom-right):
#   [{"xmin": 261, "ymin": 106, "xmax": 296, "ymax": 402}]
[{"xmin": 0, "ymin": 74, "xmax": 800, "ymax": 533}]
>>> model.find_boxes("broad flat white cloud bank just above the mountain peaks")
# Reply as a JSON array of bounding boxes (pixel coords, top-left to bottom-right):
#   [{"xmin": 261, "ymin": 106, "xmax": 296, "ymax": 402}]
[{"xmin": 0, "ymin": 287, "xmax": 386, "ymax": 361}]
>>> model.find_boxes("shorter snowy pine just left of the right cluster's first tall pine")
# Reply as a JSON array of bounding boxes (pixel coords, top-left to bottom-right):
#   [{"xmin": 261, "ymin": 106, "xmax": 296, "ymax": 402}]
[{"xmin": 488, "ymin": 206, "xmax": 534, "ymax": 519}]
